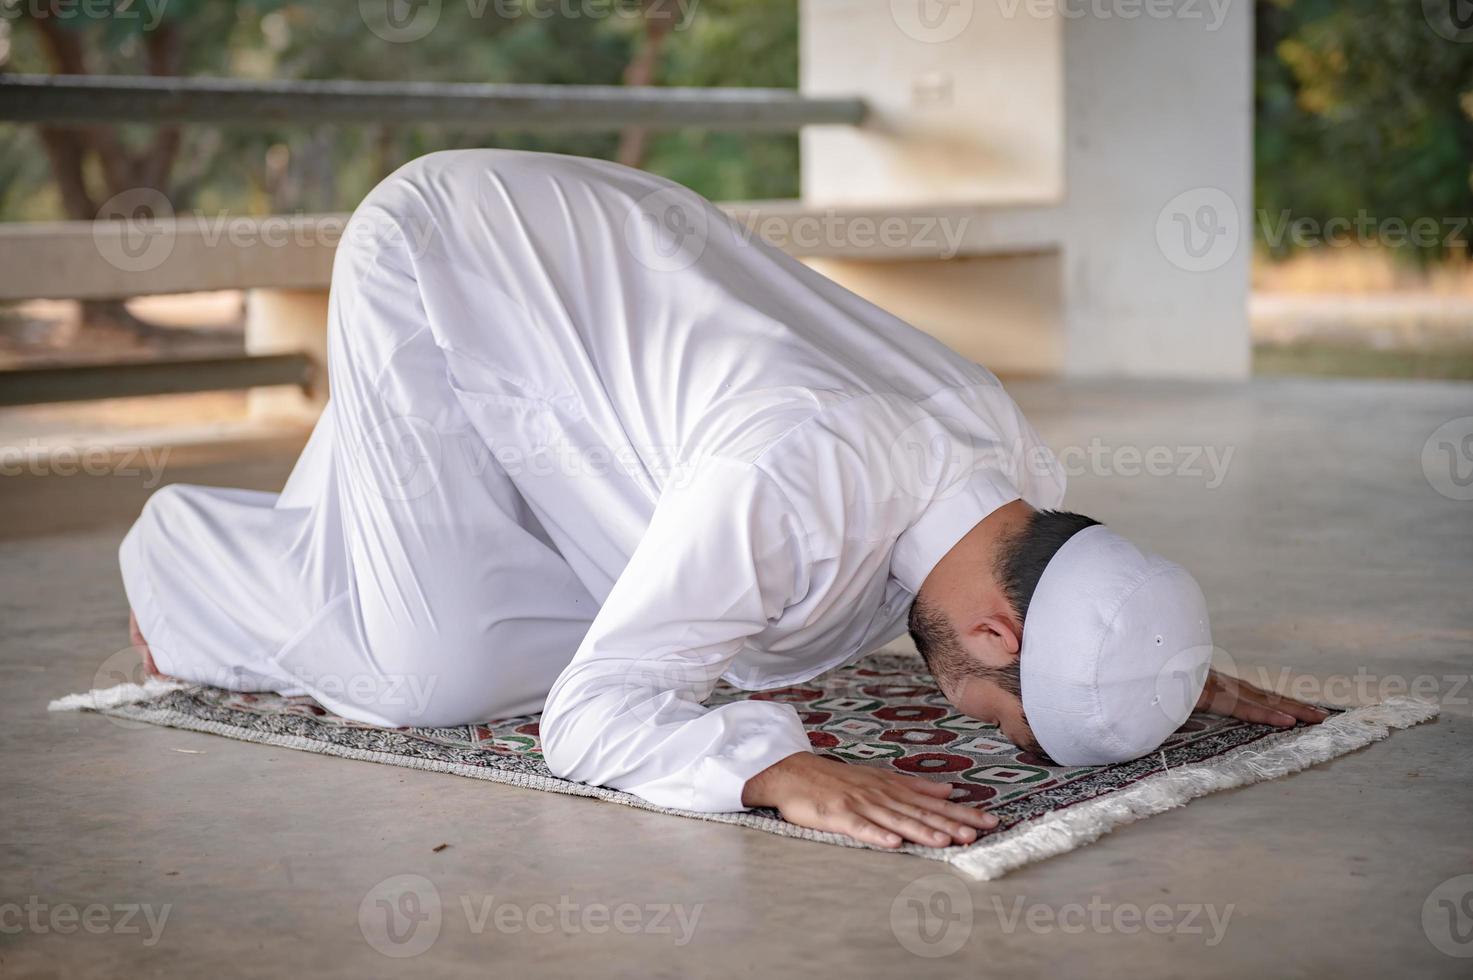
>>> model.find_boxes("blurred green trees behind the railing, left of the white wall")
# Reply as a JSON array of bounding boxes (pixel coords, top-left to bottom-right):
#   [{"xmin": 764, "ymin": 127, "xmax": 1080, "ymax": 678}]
[{"xmin": 0, "ymin": 0, "xmax": 798, "ymax": 220}]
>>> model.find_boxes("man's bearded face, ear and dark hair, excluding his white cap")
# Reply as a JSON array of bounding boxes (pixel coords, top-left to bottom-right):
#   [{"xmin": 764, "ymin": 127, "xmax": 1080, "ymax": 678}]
[{"xmin": 909, "ymin": 501, "xmax": 1099, "ymax": 756}]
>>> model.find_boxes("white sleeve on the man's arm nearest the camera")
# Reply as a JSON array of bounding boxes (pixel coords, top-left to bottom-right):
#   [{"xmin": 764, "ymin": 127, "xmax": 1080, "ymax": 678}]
[{"xmin": 542, "ymin": 458, "xmax": 809, "ymax": 811}]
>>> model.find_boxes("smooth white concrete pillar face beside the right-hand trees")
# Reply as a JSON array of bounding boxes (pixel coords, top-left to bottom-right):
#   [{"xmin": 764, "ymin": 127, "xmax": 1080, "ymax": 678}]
[{"xmin": 1064, "ymin": 0, "xmax": 1254, "ymax": 377}]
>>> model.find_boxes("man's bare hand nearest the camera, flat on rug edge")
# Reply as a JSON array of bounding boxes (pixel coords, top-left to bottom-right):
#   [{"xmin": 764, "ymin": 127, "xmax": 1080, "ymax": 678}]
[{"xmin": 741, "ymin": 752, "xmax": 997, "ymax": 847}]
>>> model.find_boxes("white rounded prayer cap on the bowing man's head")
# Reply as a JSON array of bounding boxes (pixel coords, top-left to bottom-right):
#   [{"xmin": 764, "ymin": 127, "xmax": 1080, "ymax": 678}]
[{"xmin": 1021, "ymin": 525, "xmax": 1212, "ymax": 765}]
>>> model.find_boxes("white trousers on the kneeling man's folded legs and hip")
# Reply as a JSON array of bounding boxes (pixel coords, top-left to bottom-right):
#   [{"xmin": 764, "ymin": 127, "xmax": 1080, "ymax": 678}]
[{"xmin": 121, "ymin": 171, "xmax": 598, "ymax": 725}]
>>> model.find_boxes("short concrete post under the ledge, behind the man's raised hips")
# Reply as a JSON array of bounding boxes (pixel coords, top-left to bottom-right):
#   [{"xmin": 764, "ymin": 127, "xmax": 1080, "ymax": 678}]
[{"xmin": 246, "ymin": 289, "xmax": 327, "ymax": 420}]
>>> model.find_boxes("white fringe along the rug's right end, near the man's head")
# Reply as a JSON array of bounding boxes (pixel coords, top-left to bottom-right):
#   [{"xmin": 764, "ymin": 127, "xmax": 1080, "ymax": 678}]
[{"xmin": 946, "ymin": 697, "xmax": 1439, "ymax": 881}]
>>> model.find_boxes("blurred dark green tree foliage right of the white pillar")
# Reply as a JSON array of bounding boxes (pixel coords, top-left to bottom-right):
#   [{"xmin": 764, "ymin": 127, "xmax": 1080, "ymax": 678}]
[{"xmin": 1255, "ymin": 0, "xmax": 1473, "ymax": 261}]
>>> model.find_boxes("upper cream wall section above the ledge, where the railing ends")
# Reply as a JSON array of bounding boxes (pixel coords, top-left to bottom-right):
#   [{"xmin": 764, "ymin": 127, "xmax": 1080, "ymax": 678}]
[{"xmin": 800, "ymin": 0, "xmax": 1064, "ymax": 206}]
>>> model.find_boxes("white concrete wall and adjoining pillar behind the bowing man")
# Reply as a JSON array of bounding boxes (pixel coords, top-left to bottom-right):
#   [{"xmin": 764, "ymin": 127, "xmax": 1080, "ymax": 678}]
[{"xmin": 801, "ymin": 0, "xmax": 1252, "ymax": 377}]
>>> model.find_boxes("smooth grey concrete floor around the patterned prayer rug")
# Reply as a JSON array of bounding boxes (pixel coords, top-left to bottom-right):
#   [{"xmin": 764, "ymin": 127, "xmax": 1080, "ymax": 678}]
[{"xmin": 0, "ymin": 375, "xmax": 1473, "ymax": 977}]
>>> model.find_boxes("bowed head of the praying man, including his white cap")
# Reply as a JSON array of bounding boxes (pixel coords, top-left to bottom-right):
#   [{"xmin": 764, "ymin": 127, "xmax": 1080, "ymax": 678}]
[{"xmin": 910, "ymin": 501, "xmax": 1211, "ymax": 765}]
